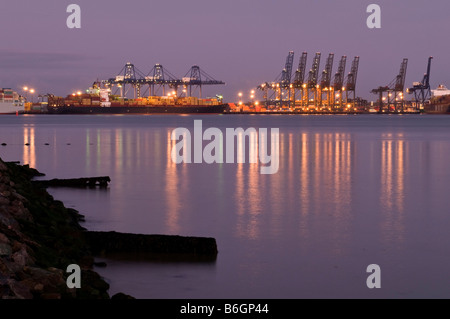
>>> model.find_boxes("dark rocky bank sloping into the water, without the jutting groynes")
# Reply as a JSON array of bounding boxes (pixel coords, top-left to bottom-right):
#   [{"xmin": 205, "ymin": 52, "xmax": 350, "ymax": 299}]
[{"xmin": 0, "ymin": 159, "xmax": 119, "ymax": 299}]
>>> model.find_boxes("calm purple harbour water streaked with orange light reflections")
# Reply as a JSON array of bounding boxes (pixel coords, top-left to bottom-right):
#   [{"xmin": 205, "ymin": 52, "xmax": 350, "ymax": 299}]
[{"xmin": 0, "ymin": 115, "xmax": 450, "ymax": 299}]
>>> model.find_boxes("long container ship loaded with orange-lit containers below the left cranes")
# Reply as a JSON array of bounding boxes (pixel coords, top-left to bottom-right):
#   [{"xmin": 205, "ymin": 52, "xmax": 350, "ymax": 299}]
[{"xmin": 46, "ymin": 85, "xmax": 228, "ymax": 114}]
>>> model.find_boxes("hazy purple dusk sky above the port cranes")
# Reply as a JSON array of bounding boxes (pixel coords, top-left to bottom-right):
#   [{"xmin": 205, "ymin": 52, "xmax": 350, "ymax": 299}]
[{"xmin": 0, "ymin": 0, "xmax": 450, "ymax": 102}]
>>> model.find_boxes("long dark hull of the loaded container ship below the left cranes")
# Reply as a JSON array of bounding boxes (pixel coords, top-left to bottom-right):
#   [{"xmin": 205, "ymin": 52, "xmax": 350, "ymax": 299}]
[{"xmin": 47, "ymin": 104, "xmax": 227, "ymax": 114}]
